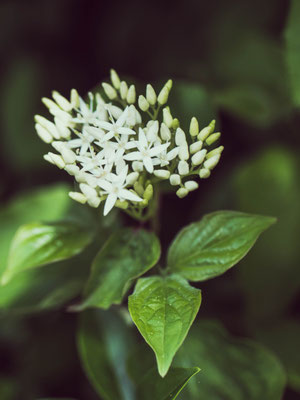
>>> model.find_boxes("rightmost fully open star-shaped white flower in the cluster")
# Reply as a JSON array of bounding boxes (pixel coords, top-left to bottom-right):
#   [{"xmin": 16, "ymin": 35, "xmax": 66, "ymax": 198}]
[{"xmin": 124, "ymin": 128, "xmax": 170, "ymax": 174}]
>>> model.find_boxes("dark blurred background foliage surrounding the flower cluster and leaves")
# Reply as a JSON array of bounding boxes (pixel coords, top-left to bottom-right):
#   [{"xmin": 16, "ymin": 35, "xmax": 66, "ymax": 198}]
[{"xmin": 0, "ymin": 0, "xmax": 300, "ymax": 400}]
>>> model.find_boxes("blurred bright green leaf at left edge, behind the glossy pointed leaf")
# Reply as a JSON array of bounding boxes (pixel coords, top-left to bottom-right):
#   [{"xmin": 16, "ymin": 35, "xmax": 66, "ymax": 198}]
[{"xmin": 0, "ymin": 184, "xmax": 72, "ymax": 273}]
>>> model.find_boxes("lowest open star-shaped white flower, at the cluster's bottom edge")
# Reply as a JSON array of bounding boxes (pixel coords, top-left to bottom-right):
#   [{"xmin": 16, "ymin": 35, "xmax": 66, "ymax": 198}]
[{"xmin": 98, "ymin": 166, "xmax": 143, "ymax": 215}]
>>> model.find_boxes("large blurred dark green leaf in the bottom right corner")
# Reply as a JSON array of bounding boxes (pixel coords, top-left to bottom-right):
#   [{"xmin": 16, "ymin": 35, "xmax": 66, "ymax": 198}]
[{"xmin": 174, "ymin": 321, "xmax": 285, "ymax": 400}]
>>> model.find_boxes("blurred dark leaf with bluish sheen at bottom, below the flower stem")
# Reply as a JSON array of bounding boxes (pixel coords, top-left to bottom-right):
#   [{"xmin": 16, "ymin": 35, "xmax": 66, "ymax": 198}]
[{"xmin": 77, "ymin": 310, "xmax": 134, "ymax": 400}]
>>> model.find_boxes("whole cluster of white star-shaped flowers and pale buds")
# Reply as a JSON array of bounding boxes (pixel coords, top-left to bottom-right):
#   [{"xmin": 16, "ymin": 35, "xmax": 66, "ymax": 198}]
[{"xmin": 35, "ymin": 70, "xmax": 223, "ymax": 217}]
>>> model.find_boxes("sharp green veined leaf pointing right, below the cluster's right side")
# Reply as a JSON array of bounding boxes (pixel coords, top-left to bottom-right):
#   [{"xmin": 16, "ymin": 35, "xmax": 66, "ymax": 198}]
[{"xmin": 168, "ymin": 211, "xmax": 276, "ymax": 281}]
